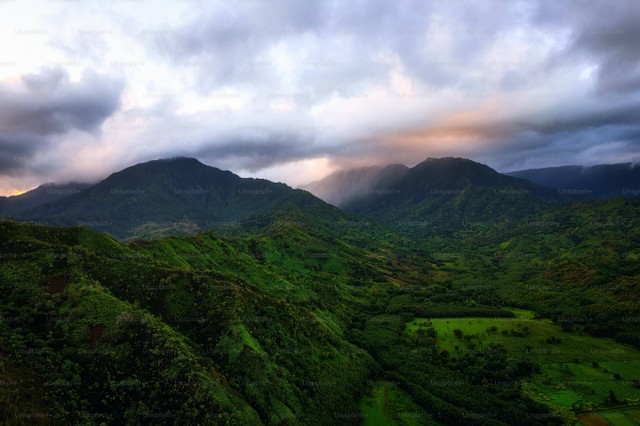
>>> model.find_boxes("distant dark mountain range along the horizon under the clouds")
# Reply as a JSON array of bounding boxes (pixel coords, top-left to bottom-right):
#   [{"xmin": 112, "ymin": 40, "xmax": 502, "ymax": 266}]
[{"xmin": 5, "ymin": 157, "xmax": 640, "ymax": 239}]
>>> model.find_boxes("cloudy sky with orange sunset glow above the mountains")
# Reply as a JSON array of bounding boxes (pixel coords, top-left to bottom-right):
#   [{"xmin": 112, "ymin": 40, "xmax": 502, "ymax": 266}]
[{"xmin": 0, "ymin": 0, "xmax": 640, "ymax": 195}]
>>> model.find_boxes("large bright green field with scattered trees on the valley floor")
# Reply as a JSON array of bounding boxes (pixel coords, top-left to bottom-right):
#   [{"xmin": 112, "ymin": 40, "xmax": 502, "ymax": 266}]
[{"xmin": 406, "ymin": 310, "xmax": 640, "ymax": 425}]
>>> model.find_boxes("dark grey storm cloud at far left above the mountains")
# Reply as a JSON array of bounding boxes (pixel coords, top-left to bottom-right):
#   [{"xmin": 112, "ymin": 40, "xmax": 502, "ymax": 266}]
[{"xmin": 0, "ymin": 69, "xmax": 122, "ymax": 175}]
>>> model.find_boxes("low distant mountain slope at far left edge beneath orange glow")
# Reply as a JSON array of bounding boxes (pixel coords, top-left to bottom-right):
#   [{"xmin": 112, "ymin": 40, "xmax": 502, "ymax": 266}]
[{"xmin": 0, "ymin": 182, "xmax": 91, "ymax": 215}]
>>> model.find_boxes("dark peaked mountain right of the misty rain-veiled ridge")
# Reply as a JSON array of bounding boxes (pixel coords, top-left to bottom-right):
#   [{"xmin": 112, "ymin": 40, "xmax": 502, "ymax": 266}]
[{"xmin": 343, "ymin": 157, "xmax": 559, "ymax": 235}]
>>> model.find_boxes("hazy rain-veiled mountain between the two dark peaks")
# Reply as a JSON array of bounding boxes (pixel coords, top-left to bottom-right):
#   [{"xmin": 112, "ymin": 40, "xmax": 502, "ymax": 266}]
[{"xmin": 301, "ymin": 164, "xmax": 409, "ymax": 207}]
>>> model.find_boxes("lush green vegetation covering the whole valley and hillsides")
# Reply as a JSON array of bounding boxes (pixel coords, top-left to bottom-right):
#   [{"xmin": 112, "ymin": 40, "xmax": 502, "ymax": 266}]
[{"xmin": 0, "ymin": 158, "xmax": 640, "ymax": 425}]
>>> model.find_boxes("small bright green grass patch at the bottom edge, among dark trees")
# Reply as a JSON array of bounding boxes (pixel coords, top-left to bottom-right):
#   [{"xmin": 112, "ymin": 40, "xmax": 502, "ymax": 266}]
[{"xmin": 360, "ymin": 382, "xmax": 439, "ymax": 426}]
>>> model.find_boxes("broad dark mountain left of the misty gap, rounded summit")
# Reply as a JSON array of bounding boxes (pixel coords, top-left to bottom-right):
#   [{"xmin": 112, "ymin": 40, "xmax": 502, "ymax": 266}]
[{"xmin": 13, "ymin": 157, "xmax": 340, "ymax": 239}]
